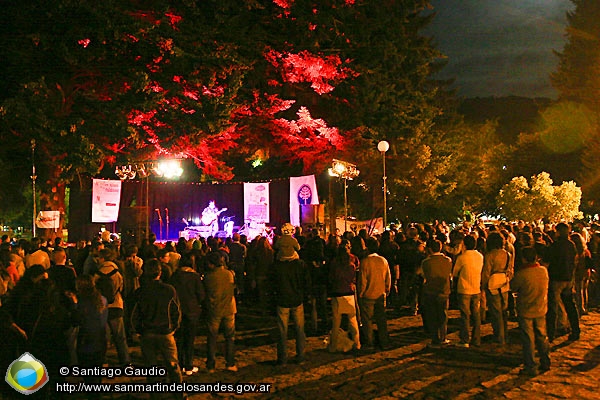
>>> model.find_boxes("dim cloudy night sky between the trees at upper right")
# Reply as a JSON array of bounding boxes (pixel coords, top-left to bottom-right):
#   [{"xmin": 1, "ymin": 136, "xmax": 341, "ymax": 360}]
[{"xmin": 426, "ymin": 0, "xmax": 574, "ymax": 98}]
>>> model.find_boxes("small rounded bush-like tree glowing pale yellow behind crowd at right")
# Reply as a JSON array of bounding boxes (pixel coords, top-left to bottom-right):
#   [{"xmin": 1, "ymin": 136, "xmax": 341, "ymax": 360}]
[{"xmin": 498, "ymin": 172, "xmax": 583, "ymax": 222}]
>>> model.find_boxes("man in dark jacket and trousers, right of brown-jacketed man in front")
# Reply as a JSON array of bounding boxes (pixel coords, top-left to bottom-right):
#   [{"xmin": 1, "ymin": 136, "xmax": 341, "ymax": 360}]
[{"xmin": 546, "ymin": 222, "xmax": 580, "ymax": 342}]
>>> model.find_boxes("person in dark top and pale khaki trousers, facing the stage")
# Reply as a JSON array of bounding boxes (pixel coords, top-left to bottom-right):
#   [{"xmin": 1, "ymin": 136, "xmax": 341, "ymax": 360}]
[{"xmin": 329, "ymin": 239, "xmax": 360, "ymax": 351}]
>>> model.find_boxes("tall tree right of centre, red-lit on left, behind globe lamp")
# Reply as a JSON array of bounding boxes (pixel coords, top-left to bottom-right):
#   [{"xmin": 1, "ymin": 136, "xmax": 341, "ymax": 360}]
[{"xmin": 237, "ymin": 0, "xmax": 456, "ymax": 219}]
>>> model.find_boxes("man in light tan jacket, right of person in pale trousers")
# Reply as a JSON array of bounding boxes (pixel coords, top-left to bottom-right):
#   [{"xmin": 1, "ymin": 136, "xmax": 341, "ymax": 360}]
[{"xmin": 358, "ymin": 238, "xmax": 392, "ymax": 349}]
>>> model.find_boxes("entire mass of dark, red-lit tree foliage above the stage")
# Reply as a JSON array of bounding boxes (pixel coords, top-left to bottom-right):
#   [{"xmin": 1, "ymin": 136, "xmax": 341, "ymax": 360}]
[{"xmin": 0, "ymin": 0, "xmax": 445, "ymax": 227}]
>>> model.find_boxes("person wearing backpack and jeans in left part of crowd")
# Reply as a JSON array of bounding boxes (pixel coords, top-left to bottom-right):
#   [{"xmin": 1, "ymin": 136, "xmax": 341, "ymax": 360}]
[{"xmin": 95, "ymin": 248, "xmax": 131, "ymax": 365}]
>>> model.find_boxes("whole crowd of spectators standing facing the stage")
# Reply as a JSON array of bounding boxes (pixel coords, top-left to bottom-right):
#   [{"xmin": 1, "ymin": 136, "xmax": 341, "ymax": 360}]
[{"xmin": 0, "ymin": 222, "xmax": 600, "ymax": 396}]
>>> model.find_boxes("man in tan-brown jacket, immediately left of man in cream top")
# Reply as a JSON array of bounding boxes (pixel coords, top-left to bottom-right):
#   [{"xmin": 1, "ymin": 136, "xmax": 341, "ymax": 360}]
[{"xmin": 417, "ymin": 239, "xmax": 452, "ymax": 346}]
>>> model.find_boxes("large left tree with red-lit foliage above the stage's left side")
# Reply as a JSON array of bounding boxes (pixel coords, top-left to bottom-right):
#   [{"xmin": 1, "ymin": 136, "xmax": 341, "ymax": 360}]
[{"xmin": 1, "ymin": 1, "xmax": 246, "ymax": 222}]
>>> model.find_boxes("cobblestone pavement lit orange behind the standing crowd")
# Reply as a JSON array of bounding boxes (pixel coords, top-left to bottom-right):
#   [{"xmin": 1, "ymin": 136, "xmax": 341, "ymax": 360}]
[{"xmin": 95, "ymin": 307, "xmax": 600, "ymax": 400}]
